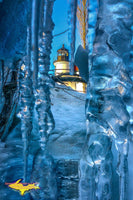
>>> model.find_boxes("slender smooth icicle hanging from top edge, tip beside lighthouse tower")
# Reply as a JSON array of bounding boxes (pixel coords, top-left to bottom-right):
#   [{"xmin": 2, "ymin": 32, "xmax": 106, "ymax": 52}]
[{"xmin": 68, "ymin": 0, "xmax": 77, "ymax": 74}]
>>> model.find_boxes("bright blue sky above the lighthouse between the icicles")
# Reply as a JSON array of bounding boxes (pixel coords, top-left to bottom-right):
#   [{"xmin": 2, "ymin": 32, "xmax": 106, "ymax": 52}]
[{"xmin": 51, "ymin": 0, "xmax": 80, "ymax": 67}]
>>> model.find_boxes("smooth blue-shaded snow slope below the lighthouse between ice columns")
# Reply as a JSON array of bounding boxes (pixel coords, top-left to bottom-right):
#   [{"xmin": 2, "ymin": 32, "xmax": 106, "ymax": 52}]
[{"xmin": 48, "ymin": 85, "xmax": 86, "ymax": 159}]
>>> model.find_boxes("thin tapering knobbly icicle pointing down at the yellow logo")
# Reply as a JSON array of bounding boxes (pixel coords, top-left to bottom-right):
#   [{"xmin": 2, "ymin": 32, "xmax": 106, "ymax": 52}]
[{"xmin": 19, "ymin": 22, "xmax": 34, "ymax": 181}]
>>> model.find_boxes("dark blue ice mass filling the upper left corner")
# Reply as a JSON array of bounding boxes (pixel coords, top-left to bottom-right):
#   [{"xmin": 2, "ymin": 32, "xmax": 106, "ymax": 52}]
[{"xmin": 0, "ymin": 0, "xmax": 30, "ymax": 62}]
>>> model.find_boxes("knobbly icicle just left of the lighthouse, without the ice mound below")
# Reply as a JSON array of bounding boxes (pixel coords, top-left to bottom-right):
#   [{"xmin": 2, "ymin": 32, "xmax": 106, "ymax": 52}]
[{"xmin": 36, "ymin": 1, "xmax": 54, "ymax": 149}]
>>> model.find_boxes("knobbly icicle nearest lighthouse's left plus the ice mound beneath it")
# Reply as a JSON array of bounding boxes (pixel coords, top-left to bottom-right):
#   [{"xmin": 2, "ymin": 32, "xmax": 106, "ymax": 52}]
[{"xmin": 31, "ymin": 0, "xmax": 56, "ymax": 200}]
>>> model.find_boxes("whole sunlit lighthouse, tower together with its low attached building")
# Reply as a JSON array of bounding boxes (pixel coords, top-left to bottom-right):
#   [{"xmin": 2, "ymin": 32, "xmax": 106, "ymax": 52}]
[{"xmin": 54, "ymin": 44, "xmax": 86, "ymax": 93}]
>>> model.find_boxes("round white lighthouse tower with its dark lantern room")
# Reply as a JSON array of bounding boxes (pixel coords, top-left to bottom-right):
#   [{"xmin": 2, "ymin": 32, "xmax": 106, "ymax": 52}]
[{"xmin": 54, "ymin": 44, "xmax": 69, "ymax": 75}]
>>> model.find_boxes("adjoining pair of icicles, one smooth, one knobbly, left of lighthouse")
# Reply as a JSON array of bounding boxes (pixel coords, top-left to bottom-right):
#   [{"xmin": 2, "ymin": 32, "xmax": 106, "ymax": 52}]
[{"xmin": 32, "ymin": 0, "xmax": 54, "ymax": 150}]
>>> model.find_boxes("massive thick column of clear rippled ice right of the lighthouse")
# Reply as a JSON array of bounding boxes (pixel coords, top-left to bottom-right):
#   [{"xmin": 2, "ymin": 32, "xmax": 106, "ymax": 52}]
[{"xmin": 79, "ymin": 0, "xmax": 133, "ymax": 200}]
